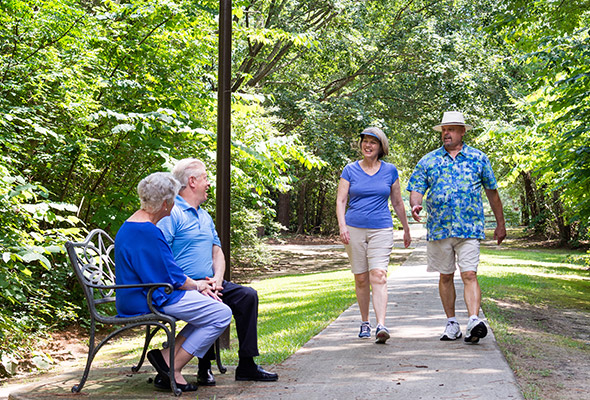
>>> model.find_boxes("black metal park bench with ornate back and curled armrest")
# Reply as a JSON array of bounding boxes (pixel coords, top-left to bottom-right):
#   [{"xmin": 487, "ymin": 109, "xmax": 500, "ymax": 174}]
[{"xmin": 66, "ymin": 229, "xmax": 226, "ymax": 396}]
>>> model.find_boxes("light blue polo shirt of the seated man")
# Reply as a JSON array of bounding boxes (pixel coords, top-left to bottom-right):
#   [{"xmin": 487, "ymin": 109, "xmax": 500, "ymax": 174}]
[{"xmin": 158, "ymin": 196, "xmax": 221, "ymax": 279}]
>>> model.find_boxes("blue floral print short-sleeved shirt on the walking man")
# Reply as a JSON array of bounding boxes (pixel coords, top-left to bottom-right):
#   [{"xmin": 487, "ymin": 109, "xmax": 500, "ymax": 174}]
[{"xmin": 407, "ymin": 143, "xmax": 498, "ymax": 240}]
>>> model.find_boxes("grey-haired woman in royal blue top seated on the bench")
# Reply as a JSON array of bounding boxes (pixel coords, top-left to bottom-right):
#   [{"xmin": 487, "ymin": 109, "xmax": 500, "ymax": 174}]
[{"xmin": 115, "ymin": 172, "xmax": 232, "ymax": 392}]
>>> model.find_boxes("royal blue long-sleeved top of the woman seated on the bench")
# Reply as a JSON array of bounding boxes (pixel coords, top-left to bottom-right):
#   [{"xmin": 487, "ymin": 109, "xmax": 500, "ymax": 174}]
[{"xmin": 115, "ymin": 221, "xmax": 187, "ymax": 317}]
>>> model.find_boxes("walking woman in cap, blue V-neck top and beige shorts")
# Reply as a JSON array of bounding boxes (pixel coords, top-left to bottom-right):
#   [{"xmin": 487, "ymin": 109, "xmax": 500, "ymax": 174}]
[{"xmin": 336, "ymin": 127, "xmax": 412, "ymax": 343}]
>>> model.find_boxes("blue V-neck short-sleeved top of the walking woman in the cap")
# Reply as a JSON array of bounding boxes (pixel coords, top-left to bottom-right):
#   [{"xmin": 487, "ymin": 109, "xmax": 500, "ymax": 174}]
[{"xmin": 340, "ymin": 161, "xmax": 399, "ymax": 229}]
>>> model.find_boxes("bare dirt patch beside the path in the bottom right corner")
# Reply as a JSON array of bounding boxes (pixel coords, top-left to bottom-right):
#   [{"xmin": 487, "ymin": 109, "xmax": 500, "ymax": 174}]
[{"xmin": 495, "ymin": 301, "xmax": 590, "ymax": 400}]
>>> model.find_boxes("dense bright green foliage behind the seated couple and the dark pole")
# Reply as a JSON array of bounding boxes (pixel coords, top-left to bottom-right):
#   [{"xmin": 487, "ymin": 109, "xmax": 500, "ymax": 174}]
[{"xmin": 0, "ymin": 0, "xmax": 323, "ymax": 376}]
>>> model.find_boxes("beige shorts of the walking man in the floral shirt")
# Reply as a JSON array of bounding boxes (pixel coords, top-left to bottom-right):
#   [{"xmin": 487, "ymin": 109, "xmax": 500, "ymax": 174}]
[{"xmin": 426, "ymin": 238, "xmax": 479, "ymax": 274}]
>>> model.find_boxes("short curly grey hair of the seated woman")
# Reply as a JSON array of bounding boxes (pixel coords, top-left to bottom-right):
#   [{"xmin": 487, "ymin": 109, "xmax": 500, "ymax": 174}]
[{"xmin": 137, "ymin": 172, "xmax": 180, "ymax": 214}]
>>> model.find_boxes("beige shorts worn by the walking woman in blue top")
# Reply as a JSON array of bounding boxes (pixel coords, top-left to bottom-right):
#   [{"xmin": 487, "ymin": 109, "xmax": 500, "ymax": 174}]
[{"xmin": 344, "ymin": 225, "xmax": 393, "ymax": 274}]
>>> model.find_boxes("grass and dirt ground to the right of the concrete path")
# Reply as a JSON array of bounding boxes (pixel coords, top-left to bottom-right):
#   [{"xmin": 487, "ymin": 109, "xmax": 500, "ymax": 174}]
[{"xmin": 478, "ymin": 236, "xmax": 590, "ymax": 399}]
